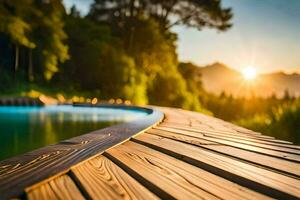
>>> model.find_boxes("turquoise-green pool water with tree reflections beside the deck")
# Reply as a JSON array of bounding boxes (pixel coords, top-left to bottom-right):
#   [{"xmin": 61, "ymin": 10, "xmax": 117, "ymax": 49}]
[{"xmin": 0, "ymin": 106, "xmax": 147, "ymax": 160}]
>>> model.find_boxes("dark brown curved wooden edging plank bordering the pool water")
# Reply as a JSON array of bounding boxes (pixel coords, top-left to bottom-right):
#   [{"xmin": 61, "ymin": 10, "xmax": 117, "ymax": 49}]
[{"xmin": 0, "ymin": 105, "xmax": 163, "ymax": 199}]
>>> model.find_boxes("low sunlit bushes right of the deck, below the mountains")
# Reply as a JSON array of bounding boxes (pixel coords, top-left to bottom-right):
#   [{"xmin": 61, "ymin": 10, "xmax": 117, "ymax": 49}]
[{"xmin": 203, "ymin": 90, "xmax": 300, "ymax": 144}]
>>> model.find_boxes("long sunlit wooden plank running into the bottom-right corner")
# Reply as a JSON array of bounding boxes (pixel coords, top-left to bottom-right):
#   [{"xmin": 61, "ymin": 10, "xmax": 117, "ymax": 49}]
[{"xmin": 133, "ymin": 134, "xmax": 300, "ymax": 199}]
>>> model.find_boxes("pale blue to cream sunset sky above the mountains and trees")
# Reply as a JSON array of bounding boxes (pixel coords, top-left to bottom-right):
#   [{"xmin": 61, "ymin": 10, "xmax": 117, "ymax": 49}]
[{"xmin": 64, "ymin": 0, "xmax": 300, "ymax": 73}]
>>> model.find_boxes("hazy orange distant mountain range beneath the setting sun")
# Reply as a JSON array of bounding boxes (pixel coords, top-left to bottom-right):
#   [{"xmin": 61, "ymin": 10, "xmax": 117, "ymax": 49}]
[{"xmin": 199, "ymin": 63, "xmax": 300, "ymax": 97}]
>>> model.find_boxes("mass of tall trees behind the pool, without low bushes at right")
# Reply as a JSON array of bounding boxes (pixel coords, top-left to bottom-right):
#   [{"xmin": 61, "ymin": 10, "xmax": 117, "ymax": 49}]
[{"xmin": 0, "ymin": 0, "xmax": 232, "ymax": 110}]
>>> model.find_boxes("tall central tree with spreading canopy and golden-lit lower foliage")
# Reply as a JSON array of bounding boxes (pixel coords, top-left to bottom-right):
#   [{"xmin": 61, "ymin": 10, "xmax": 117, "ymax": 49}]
[{"xmin": 88, "ymin": 0, "xmax": 232, "ymax": 110}]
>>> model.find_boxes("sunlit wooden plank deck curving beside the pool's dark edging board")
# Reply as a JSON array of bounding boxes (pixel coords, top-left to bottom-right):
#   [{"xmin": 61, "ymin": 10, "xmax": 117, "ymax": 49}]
[{"xmin": 0, "ymin": 107, "xmax": 300, "ymax": 200}]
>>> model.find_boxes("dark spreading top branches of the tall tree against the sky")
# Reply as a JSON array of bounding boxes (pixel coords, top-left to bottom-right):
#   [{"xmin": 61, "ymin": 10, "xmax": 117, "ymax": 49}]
[{"xmin": 90, "ymin": 0, "xmax": 232, "ymax": 31}]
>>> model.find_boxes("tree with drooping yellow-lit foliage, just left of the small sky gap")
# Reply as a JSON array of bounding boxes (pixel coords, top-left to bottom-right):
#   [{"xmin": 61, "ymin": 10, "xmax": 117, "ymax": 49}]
[{"xmin": 29, "ymin": 0, "xmax": 69, "ymax": 80}]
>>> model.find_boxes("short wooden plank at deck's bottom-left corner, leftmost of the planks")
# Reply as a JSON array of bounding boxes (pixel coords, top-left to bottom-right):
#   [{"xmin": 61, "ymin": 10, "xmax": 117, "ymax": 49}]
[{"xmin": 26, "ymin": 175, "xmax": 85, "ymax": 200}]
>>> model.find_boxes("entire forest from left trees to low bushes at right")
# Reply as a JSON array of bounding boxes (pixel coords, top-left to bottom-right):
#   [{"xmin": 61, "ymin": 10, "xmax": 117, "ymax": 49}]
[{"xmin": 0, "ymin": 0, "xmax": 300, "ymax": 144}]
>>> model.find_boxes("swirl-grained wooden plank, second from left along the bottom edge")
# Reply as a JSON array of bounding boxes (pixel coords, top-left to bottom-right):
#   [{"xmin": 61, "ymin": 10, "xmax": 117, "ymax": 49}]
[{"xmin": 71, "ymin": 155, "xmax": 158, "ymax": 199}]
